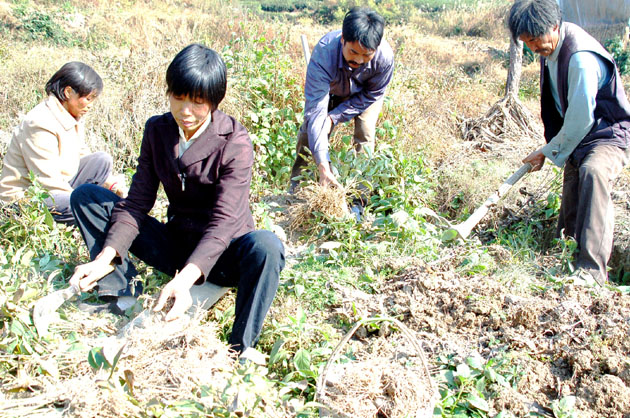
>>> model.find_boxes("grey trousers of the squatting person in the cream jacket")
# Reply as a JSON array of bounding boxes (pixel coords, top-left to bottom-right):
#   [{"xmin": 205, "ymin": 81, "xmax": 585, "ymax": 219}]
[{"xmin": 46, "ymin": 151, "xmax": 113, "ymax": 224}]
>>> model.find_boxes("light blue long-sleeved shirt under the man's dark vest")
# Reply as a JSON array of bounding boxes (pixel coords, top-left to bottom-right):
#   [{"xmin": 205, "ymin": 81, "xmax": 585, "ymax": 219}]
[{"xmin": 542, "ymin": 25, "xmax": 611, "ymax": 167}]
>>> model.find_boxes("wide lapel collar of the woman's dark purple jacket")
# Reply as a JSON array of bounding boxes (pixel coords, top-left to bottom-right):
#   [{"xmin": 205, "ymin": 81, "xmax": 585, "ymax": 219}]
[{"xmin": 171, "ymin": 110, "xmax": 234, "ymax": 167}]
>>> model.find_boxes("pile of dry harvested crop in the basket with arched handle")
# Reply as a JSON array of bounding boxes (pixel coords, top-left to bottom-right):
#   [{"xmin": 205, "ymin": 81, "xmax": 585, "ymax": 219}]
[{"xmin": 317, "ymin": 323, "xmax": 437, "ymax": 418}]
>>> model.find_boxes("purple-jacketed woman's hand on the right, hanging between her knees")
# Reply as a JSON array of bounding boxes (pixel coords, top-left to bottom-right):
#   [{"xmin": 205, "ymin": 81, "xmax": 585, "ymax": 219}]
[{"xmin": 153, "ymin": 264, "xmax": 201, "ymax": 322}]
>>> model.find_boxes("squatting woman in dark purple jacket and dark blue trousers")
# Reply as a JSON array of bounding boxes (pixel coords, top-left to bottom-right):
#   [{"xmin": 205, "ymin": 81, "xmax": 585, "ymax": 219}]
[{"xmin": 70, "ymin": 44, "xmax": 284, "ymax": 352}]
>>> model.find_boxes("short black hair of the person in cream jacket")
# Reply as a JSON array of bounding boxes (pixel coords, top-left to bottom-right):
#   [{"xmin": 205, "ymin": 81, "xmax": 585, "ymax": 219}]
[{"xmin": 46, "ymin": 61, "xmax": 103, "ymax": 103}]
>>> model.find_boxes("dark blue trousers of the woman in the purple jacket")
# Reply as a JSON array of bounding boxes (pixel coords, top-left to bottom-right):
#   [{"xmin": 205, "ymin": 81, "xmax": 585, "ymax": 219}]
[{"xmin": 70, "ymin": 185, "xmax": 284, "ymax": 351}]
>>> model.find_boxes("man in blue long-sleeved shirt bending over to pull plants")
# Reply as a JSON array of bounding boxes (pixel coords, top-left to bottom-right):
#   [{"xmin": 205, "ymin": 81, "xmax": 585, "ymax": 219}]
[{"xmin": 290, "ymin": 8, "xmax": 394, "ymax": 214}]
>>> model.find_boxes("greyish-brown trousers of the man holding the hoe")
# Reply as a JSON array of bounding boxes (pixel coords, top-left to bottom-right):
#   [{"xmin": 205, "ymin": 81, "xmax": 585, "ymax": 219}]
[{"xmin": 557, "ymin": 145, "xmax": 630, "ymax": 281}]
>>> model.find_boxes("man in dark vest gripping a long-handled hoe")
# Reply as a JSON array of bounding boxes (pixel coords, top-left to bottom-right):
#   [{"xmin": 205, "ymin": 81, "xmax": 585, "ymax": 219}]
[{"xmin": 508, "ymin": 0, "xmax": 630, "ymax": 285}]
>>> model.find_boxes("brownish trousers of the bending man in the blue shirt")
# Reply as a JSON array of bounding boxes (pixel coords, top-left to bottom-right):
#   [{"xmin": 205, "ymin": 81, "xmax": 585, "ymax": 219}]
[{"xmin": 291, "ymin": 99, "xmax": 383, "ymax": 179}]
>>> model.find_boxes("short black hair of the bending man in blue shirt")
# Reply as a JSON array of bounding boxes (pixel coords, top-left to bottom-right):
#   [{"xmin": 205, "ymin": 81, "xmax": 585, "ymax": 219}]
[{"xmin": 341, "ymin": 7, "xmax": 385, "ymax": 50}]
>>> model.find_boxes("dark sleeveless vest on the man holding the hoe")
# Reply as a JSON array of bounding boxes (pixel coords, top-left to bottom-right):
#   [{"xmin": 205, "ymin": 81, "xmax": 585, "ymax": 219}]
[{"xmin": 540, "ymin": 22, "xmax": 630, "ymax": 165}]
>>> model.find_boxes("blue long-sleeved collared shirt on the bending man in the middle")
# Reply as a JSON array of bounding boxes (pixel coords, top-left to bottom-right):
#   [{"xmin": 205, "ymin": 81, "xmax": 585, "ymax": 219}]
[{"xmin": 304, "ymin": 30, "xmax": 394, "ymax": 164}]
